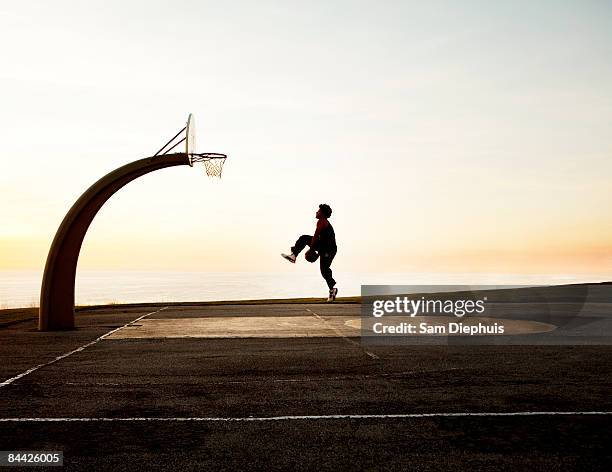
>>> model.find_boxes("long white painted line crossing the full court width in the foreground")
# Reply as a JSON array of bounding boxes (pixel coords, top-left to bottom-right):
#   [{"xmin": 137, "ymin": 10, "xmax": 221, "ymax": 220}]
[{"xmin": 0, "ymin": 411, "xmax": 612, "ymax": 423}]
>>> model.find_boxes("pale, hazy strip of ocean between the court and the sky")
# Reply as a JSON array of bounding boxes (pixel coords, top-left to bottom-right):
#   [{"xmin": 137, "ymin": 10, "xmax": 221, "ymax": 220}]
[{"xmin": 0, "ymin": 270, "xmax": 612, "ymax": 309}]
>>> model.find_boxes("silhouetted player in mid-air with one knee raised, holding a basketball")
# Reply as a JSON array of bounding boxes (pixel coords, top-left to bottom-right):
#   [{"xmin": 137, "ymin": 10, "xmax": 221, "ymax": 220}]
[{"xmin": 281, "ymin": 203, "xmax": 338, "ymax": 302}]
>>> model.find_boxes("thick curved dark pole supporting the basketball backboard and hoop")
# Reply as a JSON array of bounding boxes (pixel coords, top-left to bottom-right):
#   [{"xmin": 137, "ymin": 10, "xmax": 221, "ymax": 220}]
[{"xmin": 38, "ymin": 153, "xmax": 189, "ymax": 331}]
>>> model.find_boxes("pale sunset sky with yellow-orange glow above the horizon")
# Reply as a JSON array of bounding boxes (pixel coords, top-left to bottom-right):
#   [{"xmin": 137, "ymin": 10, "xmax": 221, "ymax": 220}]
[{"xmin": 0, "ymin": 0, "xmax": 612, "ymax": 280}]
